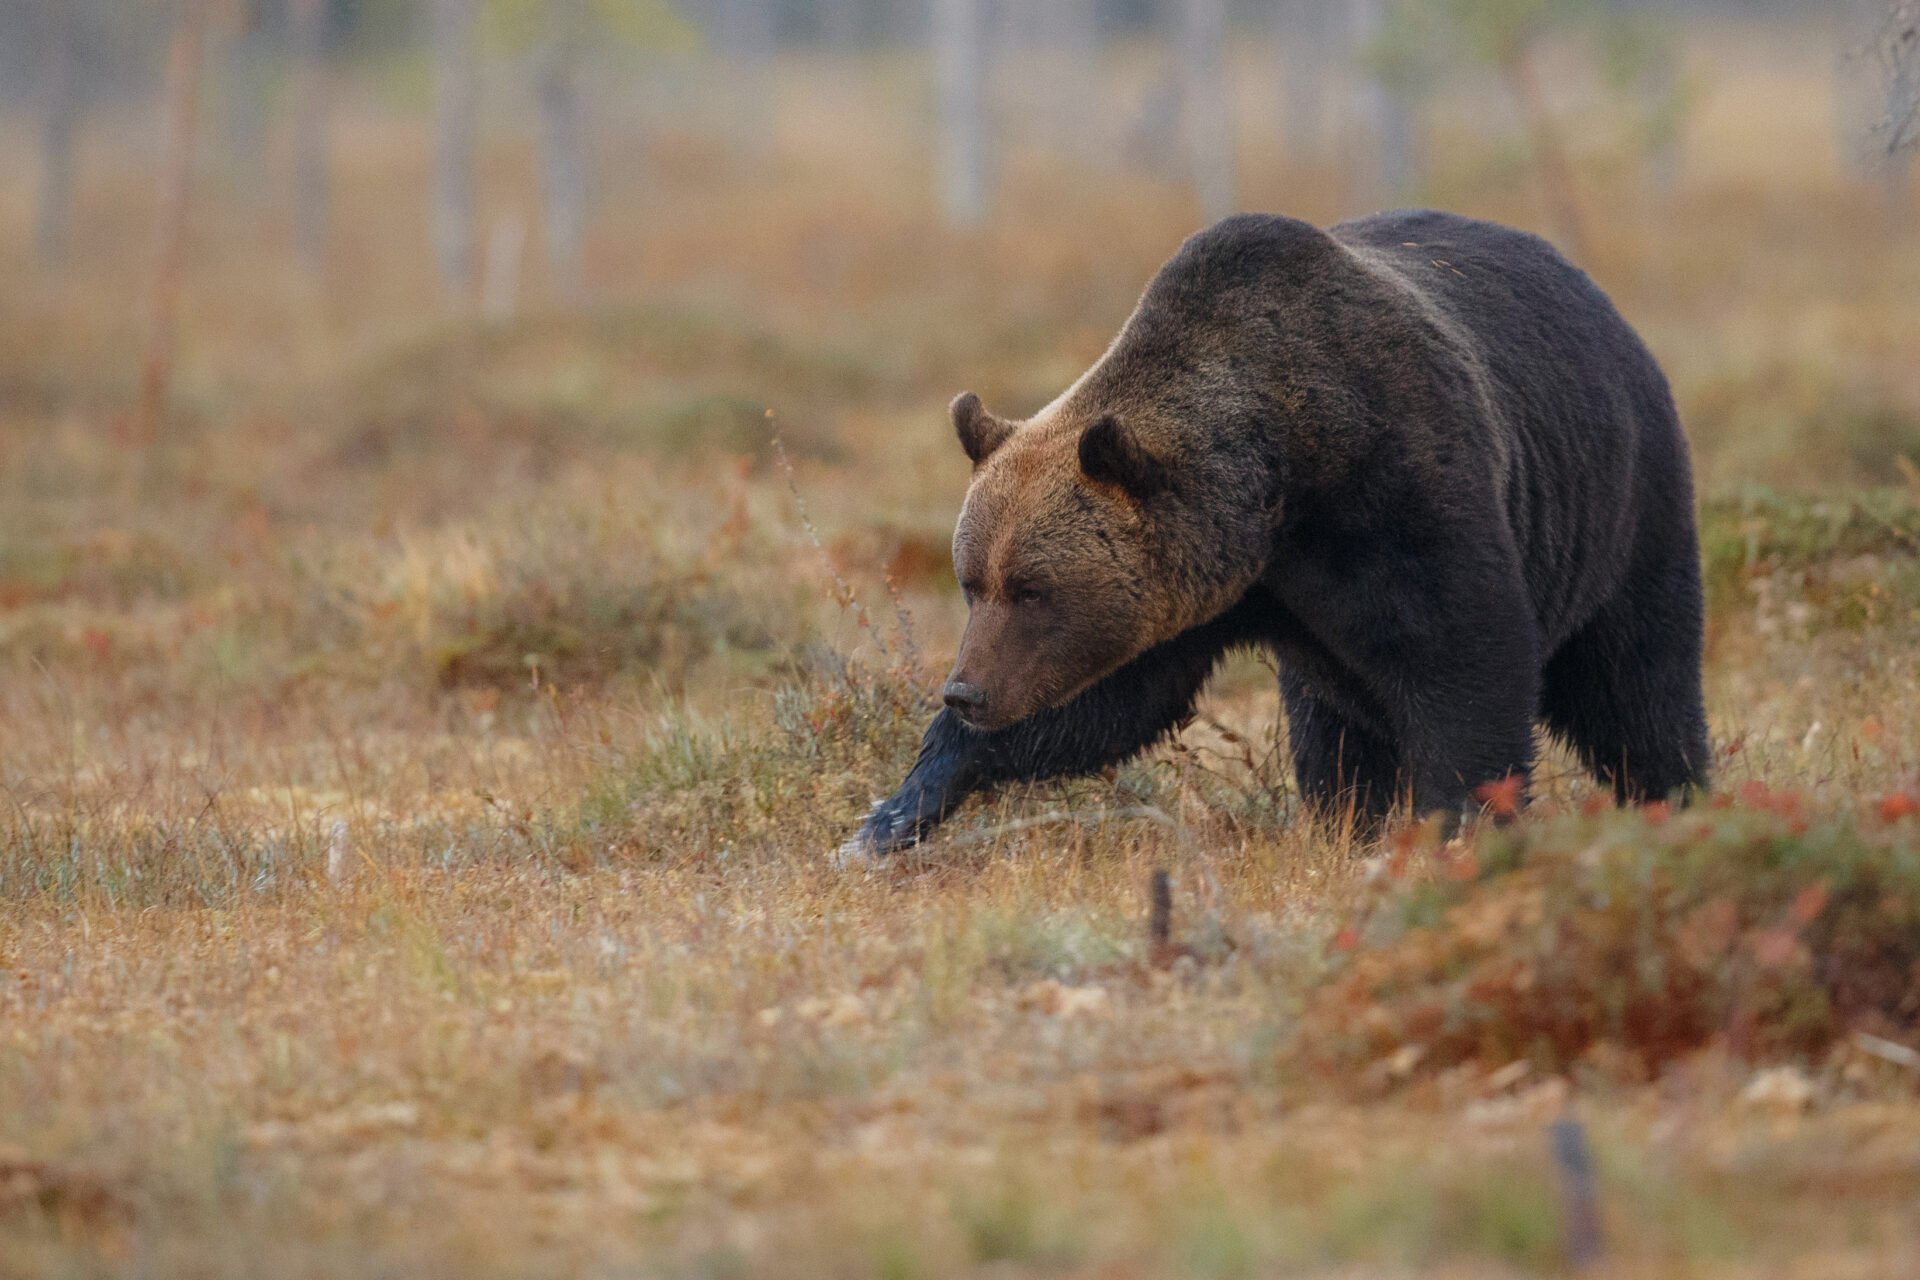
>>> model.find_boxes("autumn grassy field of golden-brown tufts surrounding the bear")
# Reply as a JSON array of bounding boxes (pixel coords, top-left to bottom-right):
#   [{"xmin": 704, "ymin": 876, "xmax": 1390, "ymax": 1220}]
[{"xmin": 0, "ymin": 22, "xmax": 1920, "ymax": 1280}]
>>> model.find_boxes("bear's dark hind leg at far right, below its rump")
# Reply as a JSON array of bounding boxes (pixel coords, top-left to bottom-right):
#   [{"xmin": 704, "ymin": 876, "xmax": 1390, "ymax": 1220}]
[{"xmin": 1542, "ymin": 555, "xmax": 1711, "ymax": 804}]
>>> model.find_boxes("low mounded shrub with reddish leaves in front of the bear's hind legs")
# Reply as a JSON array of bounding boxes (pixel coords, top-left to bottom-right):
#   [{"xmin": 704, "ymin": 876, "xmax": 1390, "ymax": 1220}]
[{"xmin": 1294, "ymin": 802, "xmax": 1920, "ymax": 1082}]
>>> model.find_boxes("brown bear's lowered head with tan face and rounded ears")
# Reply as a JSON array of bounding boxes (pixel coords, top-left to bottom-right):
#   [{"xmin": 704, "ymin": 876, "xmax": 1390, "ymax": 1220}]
[{"xmin": 945, "ymin": 393, "xmax": 1187, "ymax": 729}]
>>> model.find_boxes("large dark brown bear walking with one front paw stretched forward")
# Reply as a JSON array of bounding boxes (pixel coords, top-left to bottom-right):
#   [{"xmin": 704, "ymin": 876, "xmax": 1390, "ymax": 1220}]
[{"xmin": 845, "ymin": 211, "xmax": 1709, "ymax": 854}]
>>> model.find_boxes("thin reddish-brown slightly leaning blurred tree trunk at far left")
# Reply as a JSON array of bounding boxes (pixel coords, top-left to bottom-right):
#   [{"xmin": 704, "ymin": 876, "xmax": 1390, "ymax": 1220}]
[{"xmin": 131, "ymin": 0, "xmax": 211, "ymax": 443}]
